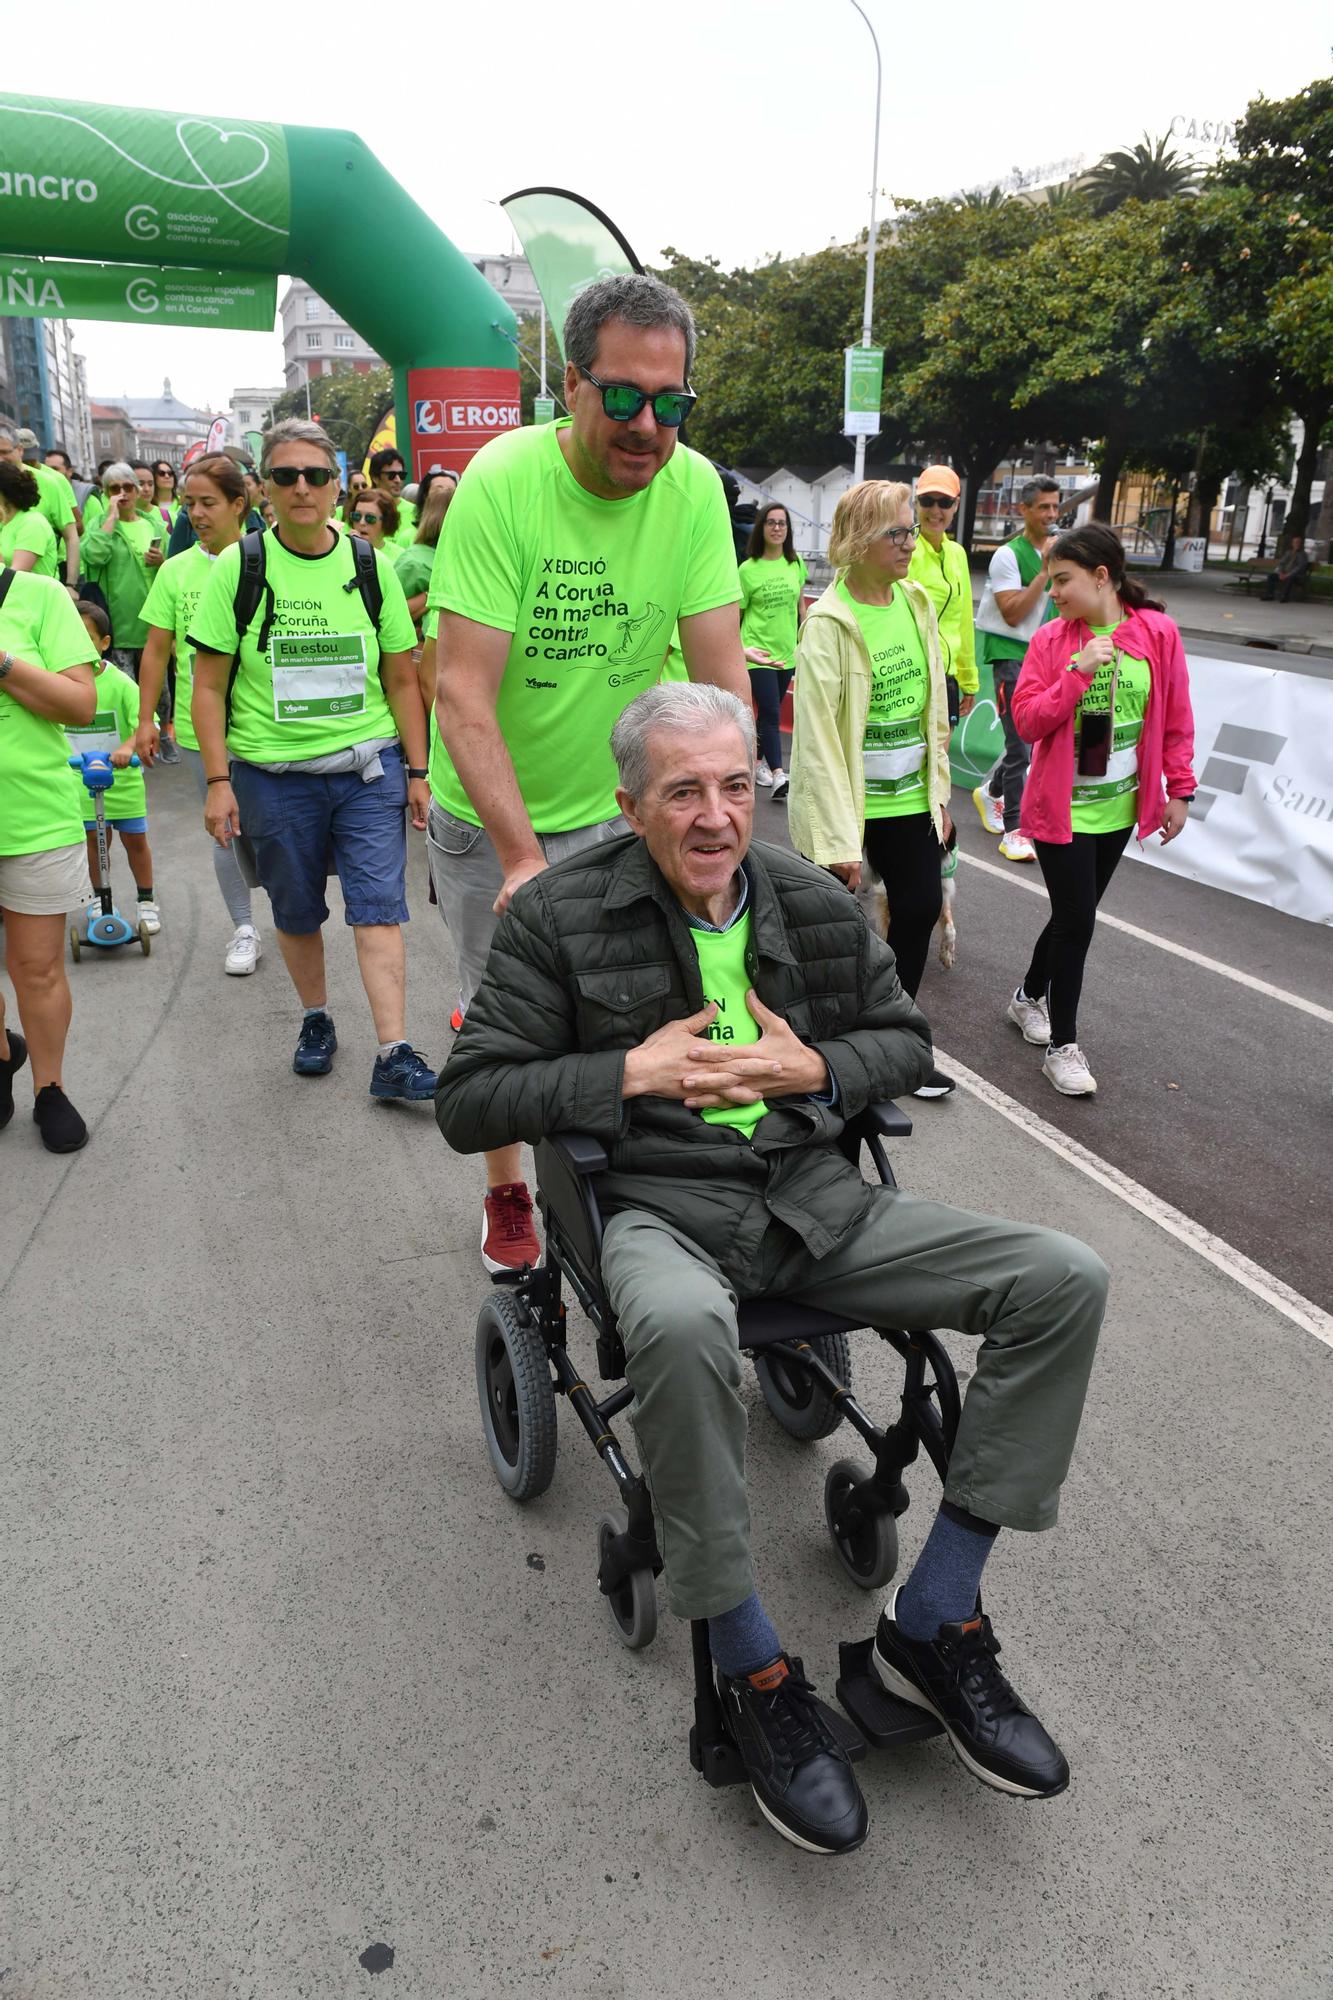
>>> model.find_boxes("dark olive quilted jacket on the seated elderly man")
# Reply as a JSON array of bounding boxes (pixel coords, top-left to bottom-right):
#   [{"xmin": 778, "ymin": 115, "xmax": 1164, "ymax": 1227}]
[{"xmin": 434, "ymin": 834, "xmax": 931, "ymax": 1272}]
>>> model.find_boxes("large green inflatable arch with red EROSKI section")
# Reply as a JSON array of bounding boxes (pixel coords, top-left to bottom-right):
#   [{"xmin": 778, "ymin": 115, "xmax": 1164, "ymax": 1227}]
[{"xmin": 0, "ymin": 92, "xmax": 518, "ymax": 478}]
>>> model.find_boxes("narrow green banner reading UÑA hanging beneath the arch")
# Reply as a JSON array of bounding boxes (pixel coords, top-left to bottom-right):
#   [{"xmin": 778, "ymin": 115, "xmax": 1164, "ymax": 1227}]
[{"xmin": 0, "ymin": 256, "xmax": 278, "ymax": 334}]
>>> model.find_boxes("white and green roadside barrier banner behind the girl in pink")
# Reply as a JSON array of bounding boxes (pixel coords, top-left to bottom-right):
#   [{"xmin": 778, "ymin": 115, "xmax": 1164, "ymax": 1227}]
[{"xmin": 953, "ymin": 652, "xmax": 1333, "ymax": 924}]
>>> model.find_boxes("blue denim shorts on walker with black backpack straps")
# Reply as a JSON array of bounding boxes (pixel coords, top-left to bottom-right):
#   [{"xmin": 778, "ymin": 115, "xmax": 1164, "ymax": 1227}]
[{"xmin": 232, "ymin": 750, "xmax": 408, "ymax": 938}]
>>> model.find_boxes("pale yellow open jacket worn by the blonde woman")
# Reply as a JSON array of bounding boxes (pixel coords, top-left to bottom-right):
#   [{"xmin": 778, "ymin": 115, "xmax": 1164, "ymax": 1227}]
[{"xmin": 787, "ymin": 580, "xmax": 953, "ymax": 868}]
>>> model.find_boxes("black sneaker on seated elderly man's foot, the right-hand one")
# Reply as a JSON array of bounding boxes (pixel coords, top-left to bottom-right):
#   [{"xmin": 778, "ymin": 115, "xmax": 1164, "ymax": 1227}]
[{"xmin": 871, "ymin": 1590, "xmax": 1069, "ymax": 1798}]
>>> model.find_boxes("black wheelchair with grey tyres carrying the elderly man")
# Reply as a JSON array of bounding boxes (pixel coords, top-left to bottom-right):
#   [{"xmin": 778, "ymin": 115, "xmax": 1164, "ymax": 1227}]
[{"xmin": 476, "ymin": 1104, "xmax": 961, "ymax": 1786}]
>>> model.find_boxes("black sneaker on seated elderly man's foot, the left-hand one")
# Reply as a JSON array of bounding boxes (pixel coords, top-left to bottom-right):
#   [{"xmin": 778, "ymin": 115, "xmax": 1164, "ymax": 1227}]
[{"xmin": 717, "ymin": 1654, "xmax": 871, "ymax": 1854}]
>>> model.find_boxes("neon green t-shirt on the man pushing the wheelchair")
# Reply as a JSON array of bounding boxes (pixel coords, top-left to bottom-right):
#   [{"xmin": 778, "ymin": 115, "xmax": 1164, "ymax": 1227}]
[{"xmin": 430, "ymin": 418, "xmax": 741, "ymax": 834}]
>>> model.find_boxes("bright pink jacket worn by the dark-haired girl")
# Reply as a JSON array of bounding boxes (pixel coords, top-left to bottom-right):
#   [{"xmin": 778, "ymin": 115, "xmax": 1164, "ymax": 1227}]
[{"xmin": 1011, "ymin": 610, "xmax": 1195, "ymax": 844}]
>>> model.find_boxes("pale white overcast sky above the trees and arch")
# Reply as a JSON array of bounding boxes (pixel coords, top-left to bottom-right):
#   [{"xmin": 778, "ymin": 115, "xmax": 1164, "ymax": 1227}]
[{"xmin": 4, "ymin": 0, "xmax": 1333, "ymax": 408}]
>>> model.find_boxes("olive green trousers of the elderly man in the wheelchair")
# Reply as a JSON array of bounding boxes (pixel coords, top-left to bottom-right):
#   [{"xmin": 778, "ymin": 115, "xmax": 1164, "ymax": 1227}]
[{"xmin": 602, "ymin": 1188, "xmax": 1109, "ymax": 1618}]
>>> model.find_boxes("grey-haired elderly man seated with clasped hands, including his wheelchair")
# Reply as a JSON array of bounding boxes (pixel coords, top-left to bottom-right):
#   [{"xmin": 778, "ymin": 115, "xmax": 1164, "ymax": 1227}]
[{"xmin": 436, "ymin": 684, "xmax": 1107, "ymax": 1854}]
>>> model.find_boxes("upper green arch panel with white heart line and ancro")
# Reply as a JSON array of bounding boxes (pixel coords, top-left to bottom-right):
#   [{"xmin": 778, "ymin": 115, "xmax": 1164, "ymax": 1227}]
[{"xmin": 0, "ymin": 92, "xmax": 292, "ymax": 272}]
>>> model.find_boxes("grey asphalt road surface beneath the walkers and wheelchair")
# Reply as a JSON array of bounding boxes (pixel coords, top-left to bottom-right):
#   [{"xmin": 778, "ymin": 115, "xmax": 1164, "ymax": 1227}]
[{"xmin": 0, "ymin": 770, "xmax": 1333, "ymax": 2000}]
